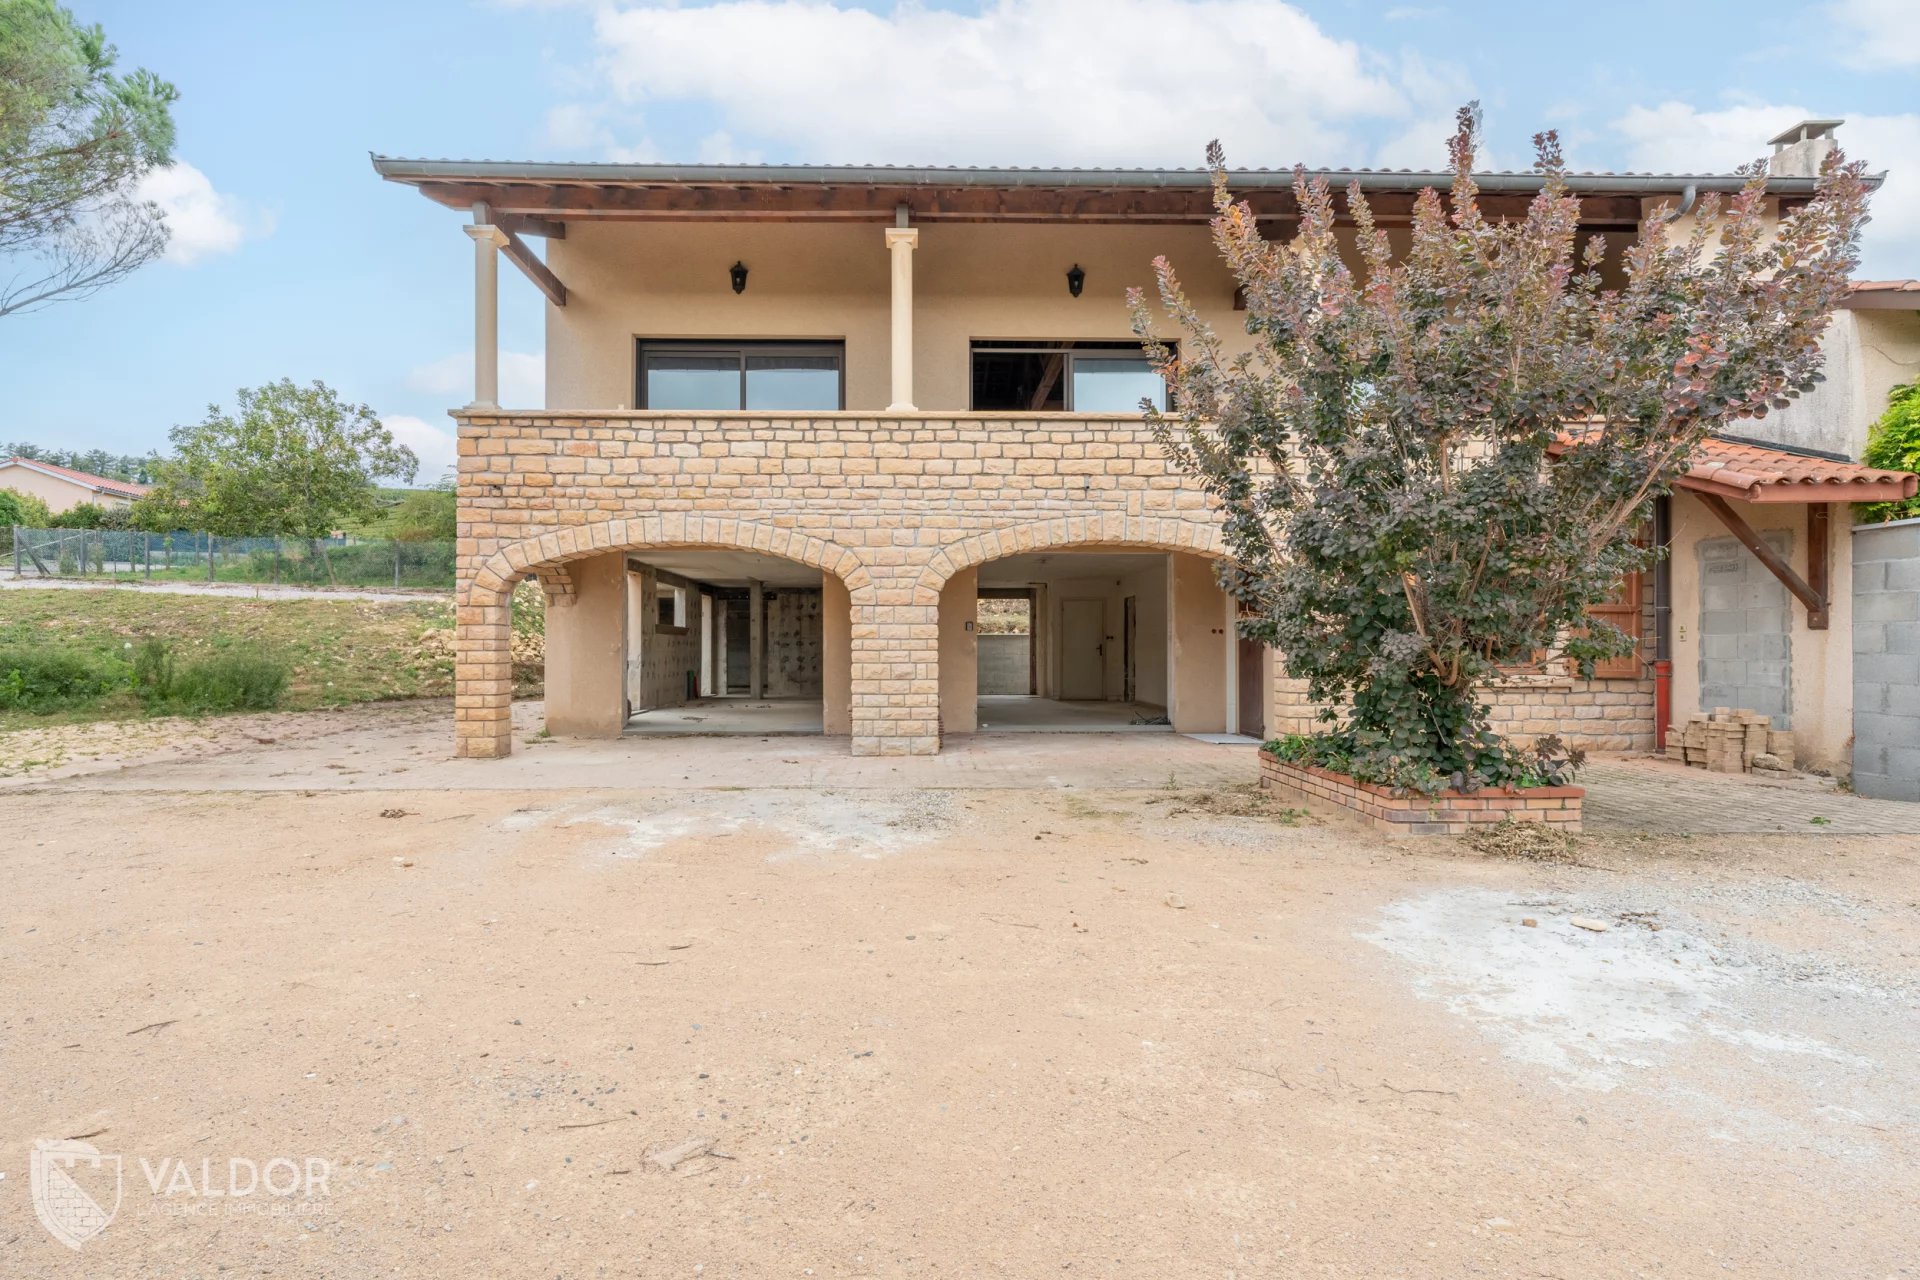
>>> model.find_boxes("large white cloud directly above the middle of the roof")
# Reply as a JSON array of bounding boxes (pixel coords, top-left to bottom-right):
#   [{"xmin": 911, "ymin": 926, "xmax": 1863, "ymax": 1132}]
[{"xmin": 576, "ymin": 0, "xmax": 1461, "ymax": 167}]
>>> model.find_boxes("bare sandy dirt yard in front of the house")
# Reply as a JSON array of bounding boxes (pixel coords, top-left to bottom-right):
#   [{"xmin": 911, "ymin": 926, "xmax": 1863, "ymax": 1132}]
[{"xmin": 0, "ymin": 725, "xmax": 1920, "ymax": 1280}]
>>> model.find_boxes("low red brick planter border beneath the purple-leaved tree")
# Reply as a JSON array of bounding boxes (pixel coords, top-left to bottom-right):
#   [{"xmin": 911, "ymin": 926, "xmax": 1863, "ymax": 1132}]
[{"xmin": 1260, "ymin": 750, "xmax": 1586, "ymax": 835}]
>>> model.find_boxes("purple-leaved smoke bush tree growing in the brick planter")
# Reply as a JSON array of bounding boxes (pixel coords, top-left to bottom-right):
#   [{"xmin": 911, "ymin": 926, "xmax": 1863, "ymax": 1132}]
[{"xmin": 1129, "ymin": 107, "xmax": 1866, "ymax": 791}]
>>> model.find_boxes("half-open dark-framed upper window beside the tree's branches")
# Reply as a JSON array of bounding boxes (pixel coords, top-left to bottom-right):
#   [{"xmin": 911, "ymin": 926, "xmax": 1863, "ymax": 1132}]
[{"xmin": 972, "ymin": 340, "xmax": 1167, "ymax": 415}]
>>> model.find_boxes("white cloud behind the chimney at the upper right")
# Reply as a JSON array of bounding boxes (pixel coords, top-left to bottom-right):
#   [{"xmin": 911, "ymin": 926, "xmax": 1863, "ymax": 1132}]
[{"xmin": 1613, "ymin": 102, "xmax": 1920, "ymax": 278}]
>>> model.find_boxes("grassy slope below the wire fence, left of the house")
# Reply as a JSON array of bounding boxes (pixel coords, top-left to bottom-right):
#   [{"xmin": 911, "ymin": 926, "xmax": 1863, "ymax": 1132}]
[{"xmin": 0, "ymin": 591, "xmax": 453, "ymax": 731}]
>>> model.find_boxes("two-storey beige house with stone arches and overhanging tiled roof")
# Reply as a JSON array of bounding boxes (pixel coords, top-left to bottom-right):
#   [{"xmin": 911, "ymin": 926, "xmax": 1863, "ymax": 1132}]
[{"xmin": 374, "ymin": 121, "xmax": 1912, "ymax": 766}]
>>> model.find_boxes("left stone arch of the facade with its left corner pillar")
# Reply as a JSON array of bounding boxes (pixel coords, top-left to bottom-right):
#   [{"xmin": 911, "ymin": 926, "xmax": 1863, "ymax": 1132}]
[{"xmin": 453, "ymin": 514, "xmax": 876, "ymax": 758}]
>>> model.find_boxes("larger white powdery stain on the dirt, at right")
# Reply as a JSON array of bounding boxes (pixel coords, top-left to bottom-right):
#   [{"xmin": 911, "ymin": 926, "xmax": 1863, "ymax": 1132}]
[{"xmin": 1361, "ymin": 889, "xmax": 1874, "ymax": 1090}]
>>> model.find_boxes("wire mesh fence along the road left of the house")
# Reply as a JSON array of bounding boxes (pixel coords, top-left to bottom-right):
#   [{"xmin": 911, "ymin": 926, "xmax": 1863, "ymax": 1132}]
[{"xmin": 10, "ymin": 526, "xmax": 453, "ymax": 591}]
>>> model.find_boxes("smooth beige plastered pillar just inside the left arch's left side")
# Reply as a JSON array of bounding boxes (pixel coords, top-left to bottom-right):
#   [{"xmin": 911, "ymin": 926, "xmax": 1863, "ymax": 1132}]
[{"xmin": 547, "ymin": 551, "xmax": 626, "ymax": 737}]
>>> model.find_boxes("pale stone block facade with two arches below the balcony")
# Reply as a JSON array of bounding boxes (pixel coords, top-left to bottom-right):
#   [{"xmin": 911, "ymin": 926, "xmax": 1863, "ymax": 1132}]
[{"xmin": 455, "ymin": 413, "xmax": 1219, "ymax": 756}]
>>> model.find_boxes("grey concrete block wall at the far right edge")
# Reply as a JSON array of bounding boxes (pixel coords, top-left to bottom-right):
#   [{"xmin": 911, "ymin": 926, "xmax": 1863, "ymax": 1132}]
[{"xmin": 1853, "ymin": 520, "xmax": 1920, "ymax": 800}]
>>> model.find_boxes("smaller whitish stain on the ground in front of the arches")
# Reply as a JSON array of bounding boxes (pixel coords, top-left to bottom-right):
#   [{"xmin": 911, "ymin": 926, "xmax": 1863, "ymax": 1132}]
[{"xmin": 501, "ymin": 789, "xmax": 952, "ymax": 862}]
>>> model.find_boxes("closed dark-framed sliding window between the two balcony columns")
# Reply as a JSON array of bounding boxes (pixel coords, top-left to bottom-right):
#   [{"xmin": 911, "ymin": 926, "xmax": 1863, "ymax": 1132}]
[{"xmin": 634, "ymin": 340, "xmax": 847, "ymax": 413}]
